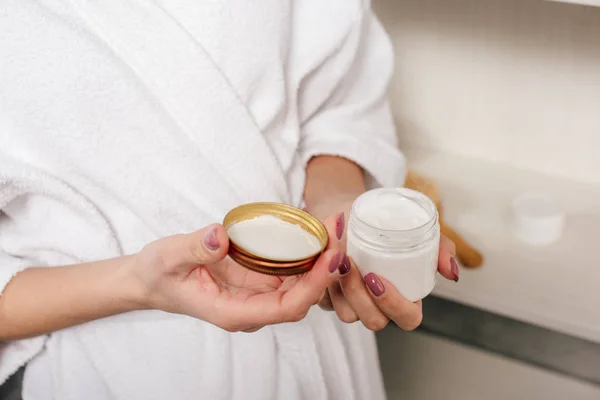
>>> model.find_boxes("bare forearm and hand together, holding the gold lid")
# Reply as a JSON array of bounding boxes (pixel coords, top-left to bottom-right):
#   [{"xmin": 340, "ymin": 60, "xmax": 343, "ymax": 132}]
[{"xmin": 0, "ymin": 225, "xmax": 344, "ymax": 341}]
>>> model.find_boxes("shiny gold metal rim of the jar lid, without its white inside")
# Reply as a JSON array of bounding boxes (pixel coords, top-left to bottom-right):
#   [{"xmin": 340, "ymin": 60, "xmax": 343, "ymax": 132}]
[{"xmin": 223, "ymin": 203, "xmax": 329, "ymax": 275}]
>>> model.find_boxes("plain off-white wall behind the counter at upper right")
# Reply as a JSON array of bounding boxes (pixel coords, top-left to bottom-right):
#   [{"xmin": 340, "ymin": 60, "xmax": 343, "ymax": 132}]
[{"xmin": 374, "ymin": 0, "xmax": 600, "ymax": 183}]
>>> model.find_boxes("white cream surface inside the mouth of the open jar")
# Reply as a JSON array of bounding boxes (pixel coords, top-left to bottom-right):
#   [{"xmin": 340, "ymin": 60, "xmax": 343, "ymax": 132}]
[{"xmin": 357, "ymin": 196, "xmax": 431, "ymax": 231}]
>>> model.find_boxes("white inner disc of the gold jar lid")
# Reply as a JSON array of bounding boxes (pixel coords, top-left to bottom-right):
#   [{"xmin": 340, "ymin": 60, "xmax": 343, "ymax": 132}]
[{"xmin": 227, "ymin": 215, "xmax": 321, "ymax": 261}]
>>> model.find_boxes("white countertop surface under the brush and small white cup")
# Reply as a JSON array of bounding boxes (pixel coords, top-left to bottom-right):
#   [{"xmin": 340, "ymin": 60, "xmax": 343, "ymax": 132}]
[{"xmin": 407, "ymin": 150, "xmax": 600, "ymax": 343}]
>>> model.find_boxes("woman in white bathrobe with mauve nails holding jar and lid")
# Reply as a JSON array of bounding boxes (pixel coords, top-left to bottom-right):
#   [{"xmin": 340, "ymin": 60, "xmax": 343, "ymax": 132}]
[{"xmin": 0, "ymin": 0, "xmax": 458, "ymax": 400}]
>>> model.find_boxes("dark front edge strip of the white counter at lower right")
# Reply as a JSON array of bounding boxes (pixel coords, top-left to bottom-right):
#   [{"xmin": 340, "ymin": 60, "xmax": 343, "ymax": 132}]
[{"xmin": 394, "ymin": 296, "xmax": 600, "ymax": 385}]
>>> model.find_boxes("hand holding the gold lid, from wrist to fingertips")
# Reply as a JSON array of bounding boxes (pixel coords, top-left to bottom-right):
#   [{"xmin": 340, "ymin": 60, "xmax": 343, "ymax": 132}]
[{"xmin": 129, "ymin": 224, "xmax": 343, "ymax": 332}]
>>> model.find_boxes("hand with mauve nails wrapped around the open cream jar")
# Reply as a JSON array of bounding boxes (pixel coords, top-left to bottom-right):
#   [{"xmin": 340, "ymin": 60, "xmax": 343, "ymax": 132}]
[{"xmin": 308, "ymin": 199, "xmax": 459, "ymax": 331}]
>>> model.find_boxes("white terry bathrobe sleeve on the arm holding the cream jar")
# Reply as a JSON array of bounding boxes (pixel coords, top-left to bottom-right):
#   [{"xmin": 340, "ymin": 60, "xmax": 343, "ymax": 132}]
[{"xmin": 299, "ymin": 7, "xmax": 406, "ymax": 186}]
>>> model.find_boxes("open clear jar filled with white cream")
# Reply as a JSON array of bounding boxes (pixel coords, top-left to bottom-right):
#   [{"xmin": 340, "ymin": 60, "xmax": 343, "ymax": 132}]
[{"xmin": 347, "ymin": 188, "xmax": 440, "ymax": 301}]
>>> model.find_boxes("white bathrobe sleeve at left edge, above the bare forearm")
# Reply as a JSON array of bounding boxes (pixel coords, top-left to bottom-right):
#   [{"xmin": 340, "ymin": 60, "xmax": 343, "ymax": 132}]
[{"xmin": 0, "ymin": 156, "xmax": 122, "ymax": 295}]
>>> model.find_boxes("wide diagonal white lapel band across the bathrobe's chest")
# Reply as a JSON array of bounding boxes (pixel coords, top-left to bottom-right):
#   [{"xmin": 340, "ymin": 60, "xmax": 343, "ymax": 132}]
[{"xmin": 72, "ymin": 0, "xmax": 289, "ymax": 202}]
